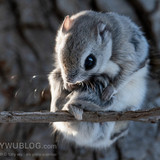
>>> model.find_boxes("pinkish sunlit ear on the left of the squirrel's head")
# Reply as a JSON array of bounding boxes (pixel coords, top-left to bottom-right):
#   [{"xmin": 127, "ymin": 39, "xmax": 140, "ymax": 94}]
[{"xmin": 62, "ymin": 15, "xmax": 73, "ymax": 33}]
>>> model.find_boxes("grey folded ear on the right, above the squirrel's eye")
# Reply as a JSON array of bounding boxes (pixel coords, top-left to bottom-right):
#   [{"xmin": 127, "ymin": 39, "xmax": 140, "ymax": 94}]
[{"xmin": 96, "ymin": 22, "xmax": 111, "ymax": 43}]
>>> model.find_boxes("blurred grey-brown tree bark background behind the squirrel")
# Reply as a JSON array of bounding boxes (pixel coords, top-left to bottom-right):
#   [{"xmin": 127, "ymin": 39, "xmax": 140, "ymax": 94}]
[{"xmin": 0, "ymin": 0, "xmax": 160, "ymax": 160}]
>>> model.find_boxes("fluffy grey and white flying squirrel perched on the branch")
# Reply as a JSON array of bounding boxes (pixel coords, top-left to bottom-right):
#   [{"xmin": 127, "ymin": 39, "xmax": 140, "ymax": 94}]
[{"xmin": 49, "ymin": 11, "xmax": 149, "ymax": 148}]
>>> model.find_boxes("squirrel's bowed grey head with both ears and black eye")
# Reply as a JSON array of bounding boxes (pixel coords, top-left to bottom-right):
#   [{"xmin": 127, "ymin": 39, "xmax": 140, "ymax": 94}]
[{"xmin": 56, "ymin": 12, "xmax": 112, "ymax": 84}]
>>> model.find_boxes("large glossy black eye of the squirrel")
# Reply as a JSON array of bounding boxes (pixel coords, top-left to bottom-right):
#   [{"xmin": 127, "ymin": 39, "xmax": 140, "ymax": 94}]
[{"xmin": 84, "ymin": 54, "xmax": 96, "ymax": 70}]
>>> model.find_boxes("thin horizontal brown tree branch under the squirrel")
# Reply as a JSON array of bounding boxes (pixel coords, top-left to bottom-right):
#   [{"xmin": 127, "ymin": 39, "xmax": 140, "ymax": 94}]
[{"xmin": 0, "ymin": 108, "xmax": 160, "ymax": 123}]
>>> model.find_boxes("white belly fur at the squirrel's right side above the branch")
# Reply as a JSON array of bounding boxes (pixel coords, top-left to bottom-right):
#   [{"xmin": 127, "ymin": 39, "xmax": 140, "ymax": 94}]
[{"xmin": 106, "ymin": 66, "xmax": 148, "ymax": 111}]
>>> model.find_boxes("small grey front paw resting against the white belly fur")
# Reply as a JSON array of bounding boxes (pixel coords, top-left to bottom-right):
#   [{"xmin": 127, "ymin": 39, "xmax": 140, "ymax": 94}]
[{"xmin": 102, "ymin": 85, "xmax": 117, "ymax": 101}]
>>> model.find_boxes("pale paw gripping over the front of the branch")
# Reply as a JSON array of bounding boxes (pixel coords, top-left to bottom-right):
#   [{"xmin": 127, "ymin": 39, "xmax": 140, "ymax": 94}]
[{"xmin": 63, "ymin": 104, "xmax": 83, "ymax": 120}]
